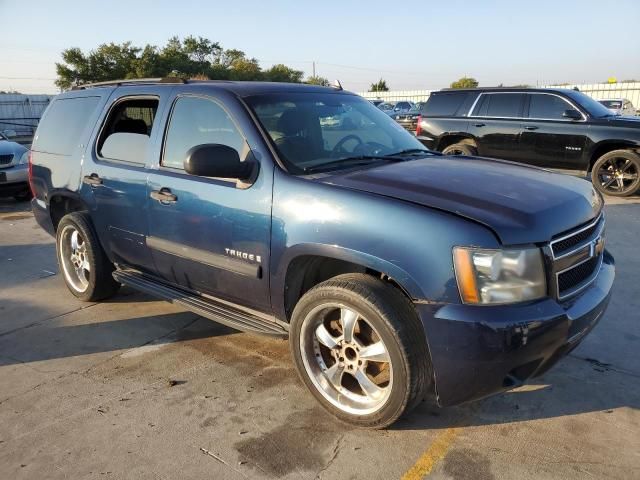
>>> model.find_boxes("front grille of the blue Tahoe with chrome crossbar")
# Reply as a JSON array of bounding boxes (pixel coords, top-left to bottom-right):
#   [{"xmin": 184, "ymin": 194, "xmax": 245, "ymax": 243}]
[{"xmin": 550, "ymin": 215, "xmax": 605, "ymax": 300}]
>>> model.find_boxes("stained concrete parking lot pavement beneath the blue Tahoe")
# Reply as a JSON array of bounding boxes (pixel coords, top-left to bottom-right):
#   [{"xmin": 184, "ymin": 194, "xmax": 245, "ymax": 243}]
[{"xmin": 0, "ymin": 198, "xmax": 640, "ymax": 480}]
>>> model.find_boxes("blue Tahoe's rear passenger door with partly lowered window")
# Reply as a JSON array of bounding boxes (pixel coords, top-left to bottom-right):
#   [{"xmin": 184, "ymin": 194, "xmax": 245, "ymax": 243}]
[{"xmin": 81, "ymin": 87, "xmax": 171, "ymax": 273}]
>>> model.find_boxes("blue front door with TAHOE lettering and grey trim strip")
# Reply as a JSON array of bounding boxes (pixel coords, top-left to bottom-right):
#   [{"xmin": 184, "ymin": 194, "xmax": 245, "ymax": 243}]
[{"xmin": 146, "ymin": 92, "xmax": 273, "ymax": 312}]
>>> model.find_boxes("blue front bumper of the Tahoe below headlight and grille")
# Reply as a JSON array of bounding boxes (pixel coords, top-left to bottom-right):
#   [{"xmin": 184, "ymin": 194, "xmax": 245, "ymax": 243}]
[{"xmin": 416, "ymin": 252, "xmax": 615, "ymax": 406}]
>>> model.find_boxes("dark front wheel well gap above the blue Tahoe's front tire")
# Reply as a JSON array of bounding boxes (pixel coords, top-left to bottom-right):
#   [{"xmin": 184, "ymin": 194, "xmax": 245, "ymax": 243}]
[{"xmin": 284, "ymin": 255, "xmax": 411, "ymax": 321}]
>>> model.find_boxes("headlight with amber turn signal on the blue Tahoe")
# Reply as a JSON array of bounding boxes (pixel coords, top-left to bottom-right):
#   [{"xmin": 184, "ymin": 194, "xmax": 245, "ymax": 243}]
[{"xmin": 453, "ymin": 247, "xmax": 547, "ymax": 304}]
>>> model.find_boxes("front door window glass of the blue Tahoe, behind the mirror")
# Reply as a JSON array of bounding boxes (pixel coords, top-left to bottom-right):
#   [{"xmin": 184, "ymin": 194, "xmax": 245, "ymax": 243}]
[{"xmin": 162, "ymin": 97, "xmax": 245, "ymax": 169}]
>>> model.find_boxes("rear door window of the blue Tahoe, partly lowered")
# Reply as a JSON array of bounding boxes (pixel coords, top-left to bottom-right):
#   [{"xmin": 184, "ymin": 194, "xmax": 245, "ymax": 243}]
[{"xmin": 97, "ymin": 97, "xmax": 159, "ymax": 165}]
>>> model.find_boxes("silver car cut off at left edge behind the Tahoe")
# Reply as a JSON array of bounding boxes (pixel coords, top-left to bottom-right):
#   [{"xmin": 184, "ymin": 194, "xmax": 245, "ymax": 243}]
[{"xmin": 0, "ymin": 133, "xmax": 31, "ymax": 200}]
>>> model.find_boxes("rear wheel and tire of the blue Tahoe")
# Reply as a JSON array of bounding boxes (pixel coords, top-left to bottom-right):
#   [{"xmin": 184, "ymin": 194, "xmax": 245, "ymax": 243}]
[{"xmin": 56, "ymin": 212, "xmax": 120, "ymax": 302}]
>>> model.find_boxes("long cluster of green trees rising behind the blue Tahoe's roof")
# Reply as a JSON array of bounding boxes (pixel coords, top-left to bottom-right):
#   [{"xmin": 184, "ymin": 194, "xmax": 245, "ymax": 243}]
[{"xmin": 56, "ymin": 36, "xmax": 303, "ymax": 89}]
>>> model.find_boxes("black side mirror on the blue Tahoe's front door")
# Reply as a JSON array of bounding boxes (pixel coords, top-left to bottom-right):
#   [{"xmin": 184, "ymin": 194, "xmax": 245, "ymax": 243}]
[{"xmin": 184, "ymin": 143, "xmax": 255, "ymax": 180}]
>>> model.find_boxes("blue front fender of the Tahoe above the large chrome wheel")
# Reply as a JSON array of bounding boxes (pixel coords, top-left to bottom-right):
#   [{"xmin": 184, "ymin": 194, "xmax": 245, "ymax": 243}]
[{"xmin": 270, "ymin": 172, "xmax": 499, "ymax": 318}]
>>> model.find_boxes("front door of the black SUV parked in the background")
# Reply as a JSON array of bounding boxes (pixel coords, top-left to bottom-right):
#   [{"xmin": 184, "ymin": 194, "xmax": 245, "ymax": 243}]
[{"xmin": 520, "ymin": 92, "xmax": 589, "ymax": 170}]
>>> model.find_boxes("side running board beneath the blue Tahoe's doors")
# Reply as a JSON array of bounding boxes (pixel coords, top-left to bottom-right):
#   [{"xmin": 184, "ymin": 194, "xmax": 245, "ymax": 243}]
[{"xmin": 113, "ymin": 270, "xmax": 287, "ymax": 336}]
